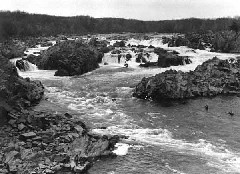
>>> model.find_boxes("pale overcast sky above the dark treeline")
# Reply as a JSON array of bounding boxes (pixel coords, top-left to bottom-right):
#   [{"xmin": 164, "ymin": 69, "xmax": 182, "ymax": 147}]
[{"xmin": 0, "ymin": 0, "xmax": 240, "ymax": 21}]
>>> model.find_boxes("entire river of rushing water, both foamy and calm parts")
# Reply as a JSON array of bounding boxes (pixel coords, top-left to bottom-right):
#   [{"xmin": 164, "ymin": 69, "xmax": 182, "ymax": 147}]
[{"xmin": 13, "ymin": 38, "xmax": 240, "ymax": 174}]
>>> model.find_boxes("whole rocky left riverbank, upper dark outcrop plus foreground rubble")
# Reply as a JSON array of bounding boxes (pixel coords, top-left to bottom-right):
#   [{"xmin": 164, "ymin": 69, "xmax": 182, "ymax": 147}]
[{"xmin": 0, "ymin": 53, "xmax": 120, "ymax": 174}]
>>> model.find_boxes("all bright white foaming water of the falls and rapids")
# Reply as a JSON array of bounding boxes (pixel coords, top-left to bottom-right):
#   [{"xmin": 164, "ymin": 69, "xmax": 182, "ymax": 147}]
[{"xmin": 12, "ymin": 36, "xmax": 240, "ymax": 173}]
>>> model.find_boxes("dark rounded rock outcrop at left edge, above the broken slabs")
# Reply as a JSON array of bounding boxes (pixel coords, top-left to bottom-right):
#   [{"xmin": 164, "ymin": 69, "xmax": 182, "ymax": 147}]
[{"xmin": 0, "ymin": 55, "xmax": 44, "ymax": 109}]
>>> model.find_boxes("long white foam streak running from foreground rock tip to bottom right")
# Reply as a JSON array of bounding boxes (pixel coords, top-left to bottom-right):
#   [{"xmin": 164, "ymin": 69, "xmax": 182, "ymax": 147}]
[{"xmin": 93, "ymin": 126, "xmax": 240, "ymax": 173}]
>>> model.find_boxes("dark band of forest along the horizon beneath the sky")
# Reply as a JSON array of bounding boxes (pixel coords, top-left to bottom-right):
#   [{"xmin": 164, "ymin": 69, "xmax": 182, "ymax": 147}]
[{"xmin": 0, "ymin": 11, "xmax": 240, "ymax": 39}]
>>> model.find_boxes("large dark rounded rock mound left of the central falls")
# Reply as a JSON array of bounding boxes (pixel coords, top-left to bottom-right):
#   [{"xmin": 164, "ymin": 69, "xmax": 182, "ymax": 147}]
[{"xmin": 36, "ymin": 41, "xmax": 99, "ymax": 76}]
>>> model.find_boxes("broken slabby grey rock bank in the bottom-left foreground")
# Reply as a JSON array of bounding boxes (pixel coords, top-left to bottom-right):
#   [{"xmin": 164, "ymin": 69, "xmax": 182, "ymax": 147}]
[{"xmin": 0, "ymin": 110, "xmax": 119, "ymax": 174}]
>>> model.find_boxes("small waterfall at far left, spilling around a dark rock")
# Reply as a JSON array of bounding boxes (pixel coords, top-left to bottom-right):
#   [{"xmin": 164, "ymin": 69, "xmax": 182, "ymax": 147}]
[{"xmin": 10, "ymin": 58, "xmax": 38, "ymax": 71}]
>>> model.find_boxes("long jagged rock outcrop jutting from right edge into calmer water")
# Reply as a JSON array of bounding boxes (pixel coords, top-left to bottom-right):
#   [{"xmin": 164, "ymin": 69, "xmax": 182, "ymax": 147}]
[{"xmin": 133, "ymin": 57, "xmax": 240, "ymax": 101}]
